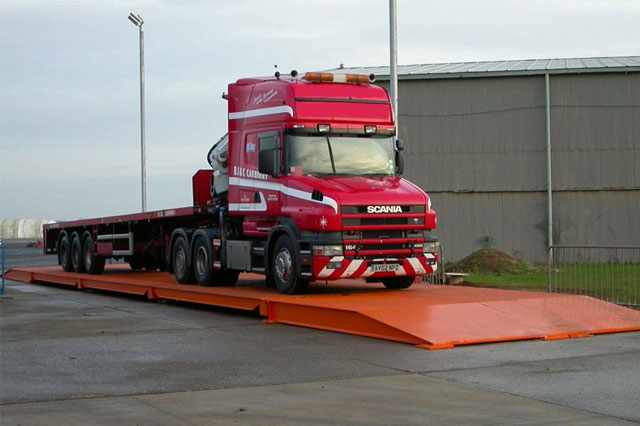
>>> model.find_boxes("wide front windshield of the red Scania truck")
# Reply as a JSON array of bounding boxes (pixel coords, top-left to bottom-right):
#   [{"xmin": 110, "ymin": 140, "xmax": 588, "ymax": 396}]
[{"xmin": 285, "ymin": 135, "xmax": 395, "ymax": 177}]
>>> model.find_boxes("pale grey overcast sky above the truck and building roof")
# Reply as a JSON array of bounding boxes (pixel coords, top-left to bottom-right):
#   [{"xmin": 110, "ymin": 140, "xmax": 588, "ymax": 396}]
[{"xmin": 0, "ymin": 0, "xmax": 640, "ymax": 220}]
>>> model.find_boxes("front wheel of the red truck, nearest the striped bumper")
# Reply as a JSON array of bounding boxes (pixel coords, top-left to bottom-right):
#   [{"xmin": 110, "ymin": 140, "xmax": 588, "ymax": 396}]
[{"xmin": 271, "ymin": 234, "xmax": 309, "ymax": 294}]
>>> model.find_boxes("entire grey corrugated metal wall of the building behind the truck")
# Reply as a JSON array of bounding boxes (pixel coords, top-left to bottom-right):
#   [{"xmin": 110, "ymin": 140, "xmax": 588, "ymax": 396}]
[{"xmin": 372, "ymin": 64, "xmax": 640, "ymax": 262}]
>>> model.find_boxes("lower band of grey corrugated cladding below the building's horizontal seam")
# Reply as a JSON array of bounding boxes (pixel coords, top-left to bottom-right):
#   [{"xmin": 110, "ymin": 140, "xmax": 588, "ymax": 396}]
[{"xmin": 432, "ymin": 190, "xmax": 640, "ymax": 262}]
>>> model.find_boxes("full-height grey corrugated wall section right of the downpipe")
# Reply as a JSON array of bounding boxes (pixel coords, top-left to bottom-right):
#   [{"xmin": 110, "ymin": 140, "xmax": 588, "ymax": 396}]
[{"xmin": 550, "ymin": 73, "xmax": 640, "ymax": 250}]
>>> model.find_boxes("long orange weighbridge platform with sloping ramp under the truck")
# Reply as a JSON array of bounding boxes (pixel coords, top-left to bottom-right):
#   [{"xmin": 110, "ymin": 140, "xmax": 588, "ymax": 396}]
[{"xmin": 6, "ymin": 265, "xmax": 640, "ymax": 349}]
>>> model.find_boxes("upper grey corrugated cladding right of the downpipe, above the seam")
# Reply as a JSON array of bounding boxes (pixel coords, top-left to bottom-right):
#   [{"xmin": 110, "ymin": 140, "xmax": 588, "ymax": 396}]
[{"xmin": 550, "ymin": 72, "xmax": 640, "ymax": 190}]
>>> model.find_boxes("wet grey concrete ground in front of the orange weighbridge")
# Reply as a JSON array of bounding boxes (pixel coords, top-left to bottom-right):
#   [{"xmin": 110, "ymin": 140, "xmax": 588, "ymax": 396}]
[{"xmin": 0, "ymin": 241, "xmax": 640, "ymax": 426}]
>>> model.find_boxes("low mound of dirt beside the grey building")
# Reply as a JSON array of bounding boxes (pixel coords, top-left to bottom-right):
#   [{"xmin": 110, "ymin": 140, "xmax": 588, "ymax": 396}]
[{"xmin": 447, "ymin": 248, "xmax": 538, "ymax": 275}]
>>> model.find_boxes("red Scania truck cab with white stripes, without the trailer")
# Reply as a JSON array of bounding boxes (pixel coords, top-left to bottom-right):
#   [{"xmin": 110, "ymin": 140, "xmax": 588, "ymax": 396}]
[{"xmin": 214, "ymin": 72, "xmax": 437, "ymax": 293}]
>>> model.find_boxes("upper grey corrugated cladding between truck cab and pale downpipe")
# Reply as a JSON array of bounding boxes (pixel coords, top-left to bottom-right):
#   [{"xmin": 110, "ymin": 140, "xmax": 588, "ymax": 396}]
[{"xmin": 378, "ymin": 77, "xmax": 546, "ymax": 192}]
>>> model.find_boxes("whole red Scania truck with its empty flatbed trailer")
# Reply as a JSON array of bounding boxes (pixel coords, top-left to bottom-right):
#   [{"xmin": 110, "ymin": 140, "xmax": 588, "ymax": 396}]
[{"xmin": 44, "ymin": 71, "xmax": 438, "ymax": 294}]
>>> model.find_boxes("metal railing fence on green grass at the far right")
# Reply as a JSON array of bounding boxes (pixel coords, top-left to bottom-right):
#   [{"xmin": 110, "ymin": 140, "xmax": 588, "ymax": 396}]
[{"xmin": 547, "ymin": 245, "xmax": 640, "ymax": 306}]
